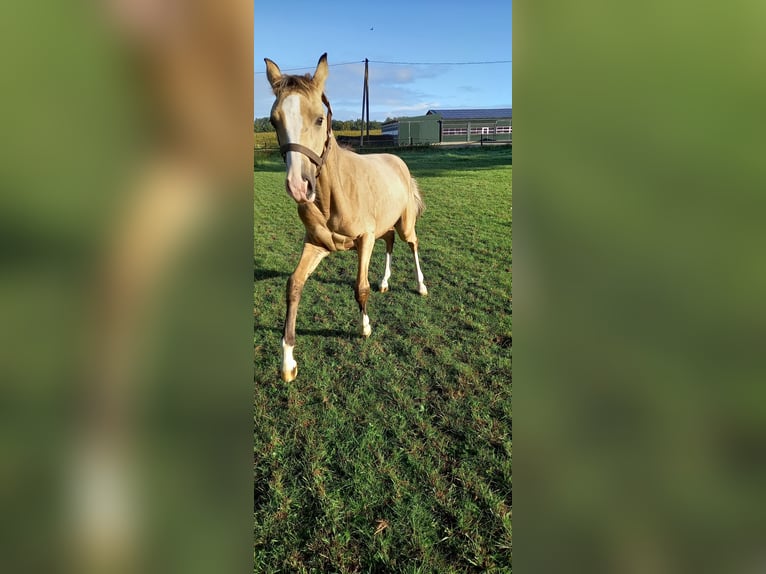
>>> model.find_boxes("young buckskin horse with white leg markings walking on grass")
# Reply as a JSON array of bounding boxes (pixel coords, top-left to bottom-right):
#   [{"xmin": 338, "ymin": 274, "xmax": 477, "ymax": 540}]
[{"xmin": 264, "ymin": 53, "xmax": 428, "ymax": 382}]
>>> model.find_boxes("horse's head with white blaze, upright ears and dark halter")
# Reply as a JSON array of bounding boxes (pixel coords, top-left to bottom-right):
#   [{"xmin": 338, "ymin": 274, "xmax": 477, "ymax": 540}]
[{"xmin": 264, "ymin": 54, "xmax": 332, "ymax": 203}]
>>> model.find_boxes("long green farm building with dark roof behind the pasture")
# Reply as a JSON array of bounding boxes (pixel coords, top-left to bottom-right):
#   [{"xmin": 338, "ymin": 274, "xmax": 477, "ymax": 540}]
[{"xmin": 381, "ymin": 108, "xmax": 513, "ymax": 145}]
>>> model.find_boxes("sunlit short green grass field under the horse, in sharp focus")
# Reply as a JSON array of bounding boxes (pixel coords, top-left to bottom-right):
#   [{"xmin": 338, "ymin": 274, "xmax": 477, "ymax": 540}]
[{"xmin": 253, "ymin": 148, "xmax": 512, "ymax": 573}]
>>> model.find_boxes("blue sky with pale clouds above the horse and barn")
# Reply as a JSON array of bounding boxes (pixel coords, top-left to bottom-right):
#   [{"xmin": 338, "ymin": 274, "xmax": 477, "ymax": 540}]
[{"xmin": 253, "ymin": 0, "xmax": 513, "ymax": 121}]
